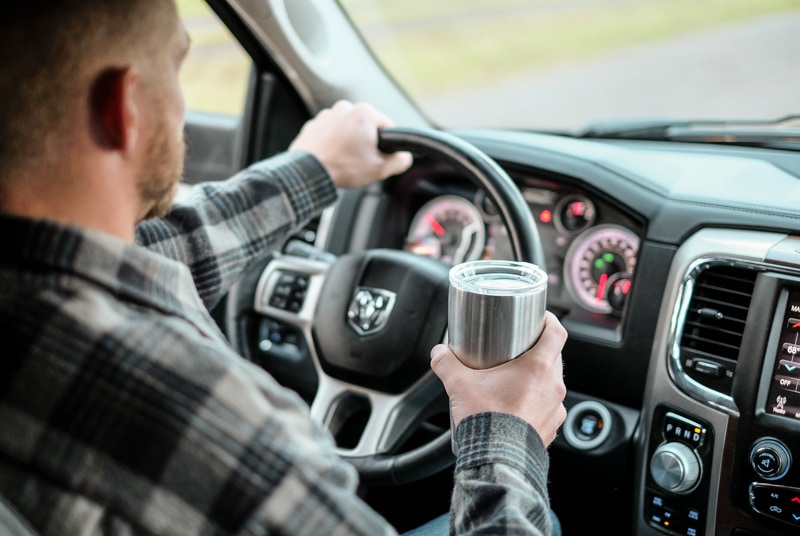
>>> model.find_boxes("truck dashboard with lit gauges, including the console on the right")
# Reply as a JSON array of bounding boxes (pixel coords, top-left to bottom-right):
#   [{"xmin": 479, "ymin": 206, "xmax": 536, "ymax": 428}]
[{"xmin": 310, "ymin": 131, "xmax": 800, "ymax": 535}]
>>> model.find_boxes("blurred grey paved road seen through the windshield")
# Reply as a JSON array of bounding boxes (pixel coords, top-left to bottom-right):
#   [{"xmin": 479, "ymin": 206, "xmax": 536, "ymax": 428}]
[{"xmin": 420, "ymin": 10, "xmax": 800, "ymax": 129}]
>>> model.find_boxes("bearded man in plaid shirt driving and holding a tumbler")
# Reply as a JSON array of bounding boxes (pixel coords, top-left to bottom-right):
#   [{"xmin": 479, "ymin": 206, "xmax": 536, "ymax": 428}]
[{"xmin": 0, "ymin": 0, "xmax": 566, "ymax": 535}]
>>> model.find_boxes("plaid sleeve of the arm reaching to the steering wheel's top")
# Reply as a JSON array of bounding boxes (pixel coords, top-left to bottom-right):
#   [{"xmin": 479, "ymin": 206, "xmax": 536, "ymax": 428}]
[{"xmin": 135, "ymin": 151, "xmax": 337, "ymax": 309}]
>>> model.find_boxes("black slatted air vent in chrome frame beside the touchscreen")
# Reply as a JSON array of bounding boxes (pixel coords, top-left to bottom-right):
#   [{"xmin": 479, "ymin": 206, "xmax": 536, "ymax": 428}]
[{"xmin": 680, "ymin": 266, "xmax": 757, "ymax": 395}]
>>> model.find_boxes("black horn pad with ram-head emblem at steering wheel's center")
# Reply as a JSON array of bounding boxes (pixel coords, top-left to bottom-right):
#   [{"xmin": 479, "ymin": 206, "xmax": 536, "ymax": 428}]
[{"xmin": 312, "ymin": 249, "xmax": 449, "ymax": 393}]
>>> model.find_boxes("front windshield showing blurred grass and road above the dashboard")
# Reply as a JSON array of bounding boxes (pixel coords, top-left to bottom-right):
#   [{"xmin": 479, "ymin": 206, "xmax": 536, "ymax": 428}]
[{"xmin": 340, "ymin": 0, "xmax": 800, "ymax": 132}]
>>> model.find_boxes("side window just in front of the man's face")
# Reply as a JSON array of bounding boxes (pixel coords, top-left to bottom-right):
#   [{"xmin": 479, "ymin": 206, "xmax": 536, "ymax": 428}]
[{"xmin": 177, "ymin": 0, "xmax": 252, "ymax": 184}]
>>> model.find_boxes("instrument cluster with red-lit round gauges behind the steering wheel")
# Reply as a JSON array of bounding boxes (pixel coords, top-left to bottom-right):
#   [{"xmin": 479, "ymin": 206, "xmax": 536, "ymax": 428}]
[{"xmin": 404, "ymin": 177, "xmax": 641, "ymax": 317}]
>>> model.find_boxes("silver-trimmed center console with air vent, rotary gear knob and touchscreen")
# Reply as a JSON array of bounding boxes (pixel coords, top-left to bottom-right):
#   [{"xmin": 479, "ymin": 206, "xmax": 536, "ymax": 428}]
[{"xmin": 635, "ymin": 229, "xmax": 800, "ymax": 536}]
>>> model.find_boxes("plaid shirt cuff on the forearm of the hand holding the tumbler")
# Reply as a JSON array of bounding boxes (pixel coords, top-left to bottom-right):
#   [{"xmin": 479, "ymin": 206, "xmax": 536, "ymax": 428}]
[{"xmin": 450, "ymin": 413, "xmax": 552, "ymax": 535}]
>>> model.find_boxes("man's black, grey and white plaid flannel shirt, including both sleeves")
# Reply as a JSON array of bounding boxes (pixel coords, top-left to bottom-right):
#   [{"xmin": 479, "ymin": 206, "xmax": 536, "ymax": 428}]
[{"xmin": 0, "ymin": 153, "xmax": 549, "ymax": 536}]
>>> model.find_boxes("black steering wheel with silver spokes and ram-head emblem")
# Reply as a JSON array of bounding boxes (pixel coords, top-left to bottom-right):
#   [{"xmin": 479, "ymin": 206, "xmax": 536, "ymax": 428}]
[{"xmin": 227, "ymin": 127, "xmax": 544, "ymax": 485}]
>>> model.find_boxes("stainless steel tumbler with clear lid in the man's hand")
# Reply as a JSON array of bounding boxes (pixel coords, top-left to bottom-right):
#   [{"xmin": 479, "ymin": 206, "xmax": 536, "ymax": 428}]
[{"xmin": 448, "ymin": 260, "xmax": 547, "ymax": 368}]
